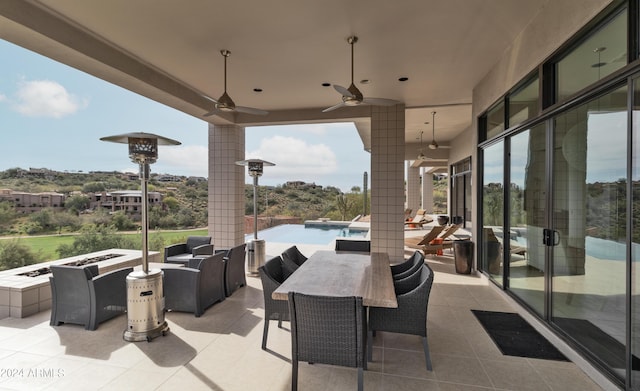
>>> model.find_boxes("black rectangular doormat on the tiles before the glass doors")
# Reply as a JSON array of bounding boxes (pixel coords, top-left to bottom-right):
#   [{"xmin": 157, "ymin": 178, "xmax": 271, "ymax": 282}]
[{"xmin": 471, "ymin": 310, "xmax": 569, "ymax": 361}]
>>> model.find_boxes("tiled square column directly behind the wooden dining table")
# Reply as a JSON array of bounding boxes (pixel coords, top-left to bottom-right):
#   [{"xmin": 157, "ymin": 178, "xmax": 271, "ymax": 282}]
[{"xmin": 371, "ymin": 105, "xmax": 404, "ymax": 262}]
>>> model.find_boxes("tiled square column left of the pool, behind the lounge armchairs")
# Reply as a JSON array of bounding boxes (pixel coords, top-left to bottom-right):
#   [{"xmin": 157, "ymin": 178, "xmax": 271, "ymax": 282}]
[{"xmin": 208, "ymin": 124, "xmax": 246, "ymax": 249}]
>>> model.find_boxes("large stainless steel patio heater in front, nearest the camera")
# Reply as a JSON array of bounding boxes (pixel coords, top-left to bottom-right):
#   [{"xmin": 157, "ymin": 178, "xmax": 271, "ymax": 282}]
[{"xmin": 100, "ymin": 132, "xmax": 180, "ymax": 342}]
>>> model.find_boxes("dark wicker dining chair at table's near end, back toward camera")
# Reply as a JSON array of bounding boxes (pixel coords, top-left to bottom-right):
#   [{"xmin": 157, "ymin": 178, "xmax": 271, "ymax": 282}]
[{"xmin": 289, "ymin": 292, "xmax": 367, "ymax": 391}]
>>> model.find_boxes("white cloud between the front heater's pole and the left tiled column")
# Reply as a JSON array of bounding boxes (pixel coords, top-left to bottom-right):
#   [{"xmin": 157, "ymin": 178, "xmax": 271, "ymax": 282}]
[{"xmin": 159, "ymin": 145, "xmax": 209, "ymax": 177}]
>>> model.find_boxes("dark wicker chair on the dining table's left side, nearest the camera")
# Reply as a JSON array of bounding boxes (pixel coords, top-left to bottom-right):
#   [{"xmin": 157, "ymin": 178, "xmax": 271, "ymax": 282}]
[{"xmin": 258, "ymin": 256, "xmax": 290, "ymax": 350}]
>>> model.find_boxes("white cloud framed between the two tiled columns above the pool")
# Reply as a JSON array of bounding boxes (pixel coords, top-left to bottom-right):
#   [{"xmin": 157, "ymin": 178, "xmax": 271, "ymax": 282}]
[{"xmin": 246, "ymin": 136, "xmax": 338, "ymax": 180}]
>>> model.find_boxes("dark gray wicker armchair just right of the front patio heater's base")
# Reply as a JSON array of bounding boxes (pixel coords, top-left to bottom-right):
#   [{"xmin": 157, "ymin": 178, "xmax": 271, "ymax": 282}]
[{"xmin": 163, "ymin": 253, "xmax": 226, "ymax": 317}]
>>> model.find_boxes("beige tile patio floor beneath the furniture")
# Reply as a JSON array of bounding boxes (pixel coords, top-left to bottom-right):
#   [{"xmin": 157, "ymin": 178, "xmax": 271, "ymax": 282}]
[{"xmin": 0, "ymin": 243, "xmax": 616, "ymax": 391}]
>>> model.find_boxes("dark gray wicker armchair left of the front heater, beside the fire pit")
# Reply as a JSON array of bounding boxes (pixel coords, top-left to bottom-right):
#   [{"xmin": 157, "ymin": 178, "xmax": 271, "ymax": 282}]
[{"xmin": 49, "ymin": 265, "xmax": 133, "ymax": 330}]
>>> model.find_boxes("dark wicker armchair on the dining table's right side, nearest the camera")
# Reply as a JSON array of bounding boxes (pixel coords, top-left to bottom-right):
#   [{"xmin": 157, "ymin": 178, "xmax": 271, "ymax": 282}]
[{"xmin": 368, "ymin": 264, "xmax": 433, "ymax": 371}]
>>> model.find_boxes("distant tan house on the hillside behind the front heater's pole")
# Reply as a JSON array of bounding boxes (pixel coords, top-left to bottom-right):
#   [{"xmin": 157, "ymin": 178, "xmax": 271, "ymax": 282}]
[{"xmin": 87, "ymin": 190, "xmax": 164, "ymax": 215}]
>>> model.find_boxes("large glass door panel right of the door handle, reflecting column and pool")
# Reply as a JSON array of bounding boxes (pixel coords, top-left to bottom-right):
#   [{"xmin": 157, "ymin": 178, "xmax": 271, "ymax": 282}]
[{"xmin": 545, "ymin": 87, "xmax": 628, "ymax": 377}]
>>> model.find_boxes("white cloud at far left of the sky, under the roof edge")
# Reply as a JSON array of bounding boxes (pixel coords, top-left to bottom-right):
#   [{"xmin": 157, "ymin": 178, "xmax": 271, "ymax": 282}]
[{"xmin": 14, "ymin": 80, "xmax": 88, "ymax": 118}]
